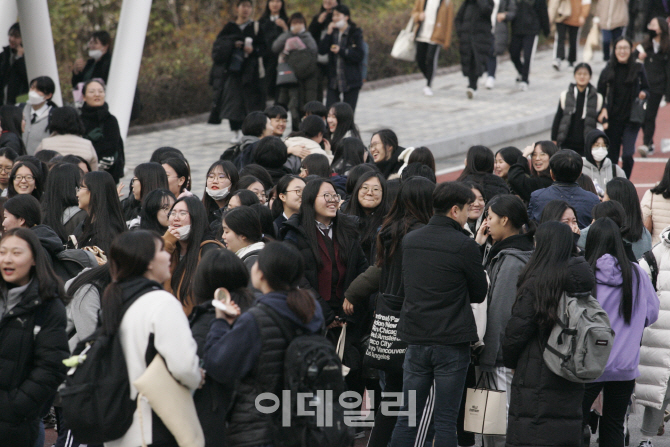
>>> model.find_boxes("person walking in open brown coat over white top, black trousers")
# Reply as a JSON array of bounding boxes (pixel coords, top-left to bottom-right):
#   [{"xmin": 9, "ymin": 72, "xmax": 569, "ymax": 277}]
[{"xmin": 412, "ymin": 0, "xmax": 454, "ymax": 96}]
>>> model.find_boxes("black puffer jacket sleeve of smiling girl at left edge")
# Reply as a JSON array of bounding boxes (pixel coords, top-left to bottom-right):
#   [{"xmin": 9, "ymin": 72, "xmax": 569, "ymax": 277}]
[{"xmin": 0, "ymin": 298, "xmax": 70, "ymax": 421}]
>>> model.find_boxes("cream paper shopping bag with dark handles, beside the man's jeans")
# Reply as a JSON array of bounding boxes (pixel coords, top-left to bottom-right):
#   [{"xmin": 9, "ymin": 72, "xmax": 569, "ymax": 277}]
[{"xmin": 463, "ymin": 373, "xmax": 507, "ymax": 435}]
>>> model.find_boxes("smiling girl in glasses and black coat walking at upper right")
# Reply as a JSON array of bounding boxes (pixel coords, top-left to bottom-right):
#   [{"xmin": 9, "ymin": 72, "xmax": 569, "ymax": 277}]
[{"xmin": 598, "ymin": 37, "xmax": 649, "ymax": 178}]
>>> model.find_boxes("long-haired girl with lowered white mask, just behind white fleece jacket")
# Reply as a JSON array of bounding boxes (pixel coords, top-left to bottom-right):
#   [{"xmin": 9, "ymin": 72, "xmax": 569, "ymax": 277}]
[{"xmin": 163, "ymin": 197, "xmax": 223, "ymax": 315}]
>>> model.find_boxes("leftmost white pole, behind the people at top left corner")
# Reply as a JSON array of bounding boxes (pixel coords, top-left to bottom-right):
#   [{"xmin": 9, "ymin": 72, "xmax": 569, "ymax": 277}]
[{"xmin": 17, "ymin": 0, "xmax": 63, "ymax": 105}]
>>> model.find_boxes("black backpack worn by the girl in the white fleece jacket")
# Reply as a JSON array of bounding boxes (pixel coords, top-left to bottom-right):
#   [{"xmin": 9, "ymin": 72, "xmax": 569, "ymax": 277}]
[{"xmin": 59, "ymin": 294, "xmax": 151, "ymax": 444}]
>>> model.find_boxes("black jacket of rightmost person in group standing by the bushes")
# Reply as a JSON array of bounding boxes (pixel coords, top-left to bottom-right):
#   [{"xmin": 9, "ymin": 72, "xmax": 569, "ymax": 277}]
[{"xmin": 319, "ymin": 25, "xmax": 365, "ymax": 93}]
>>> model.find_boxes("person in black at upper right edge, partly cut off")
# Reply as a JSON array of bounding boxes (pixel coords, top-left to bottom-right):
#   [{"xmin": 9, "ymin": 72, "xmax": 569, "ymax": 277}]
[{"xmin": 637, "ymin": 17, "xmax": 670, "ymax": 157}]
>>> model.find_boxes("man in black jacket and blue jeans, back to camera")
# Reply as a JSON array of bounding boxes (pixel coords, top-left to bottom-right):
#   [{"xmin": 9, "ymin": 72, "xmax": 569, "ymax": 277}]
[{"xmin": 391, "ymin": 182, "xmax": 488, "ymax": 447}]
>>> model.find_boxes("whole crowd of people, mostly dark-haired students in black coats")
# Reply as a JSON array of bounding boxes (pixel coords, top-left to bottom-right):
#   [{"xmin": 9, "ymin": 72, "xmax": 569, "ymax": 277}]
[{"xmin": 0, "ymin": 0, "xmax": 670, "ymax": 447}]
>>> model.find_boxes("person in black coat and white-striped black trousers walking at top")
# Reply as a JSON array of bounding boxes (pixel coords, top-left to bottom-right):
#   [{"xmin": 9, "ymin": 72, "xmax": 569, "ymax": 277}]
[{"xmin": 509, "ymin": 0, "xmax": 550, "ymax": 91}]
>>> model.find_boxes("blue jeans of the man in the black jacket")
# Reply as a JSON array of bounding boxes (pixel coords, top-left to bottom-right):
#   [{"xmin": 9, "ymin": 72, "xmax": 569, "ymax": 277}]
[{"xmin": 391, "ymin": 343, "xmax": 470, "ymax": 447}]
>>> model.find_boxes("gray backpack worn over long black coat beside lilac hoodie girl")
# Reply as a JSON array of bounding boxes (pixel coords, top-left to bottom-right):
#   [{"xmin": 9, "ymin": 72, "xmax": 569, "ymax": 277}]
[{"xmin": 543, "ymin": 293, "xmax": 614, "ymax": 383}]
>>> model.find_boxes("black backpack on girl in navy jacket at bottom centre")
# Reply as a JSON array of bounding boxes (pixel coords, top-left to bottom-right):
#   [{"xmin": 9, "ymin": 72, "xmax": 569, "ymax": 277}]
[{"xmin": 255, "ymin": 304, "xmax": 353, "ymax": 447}]
